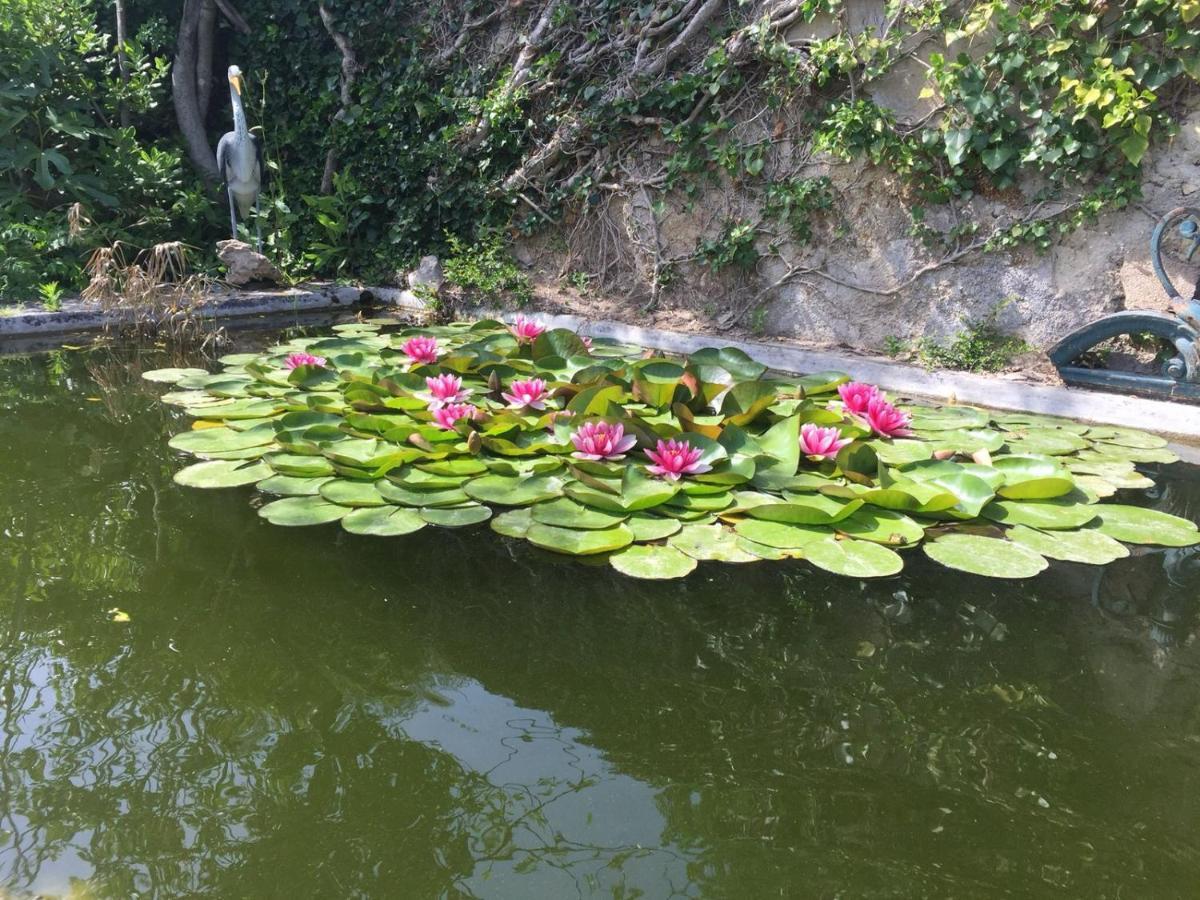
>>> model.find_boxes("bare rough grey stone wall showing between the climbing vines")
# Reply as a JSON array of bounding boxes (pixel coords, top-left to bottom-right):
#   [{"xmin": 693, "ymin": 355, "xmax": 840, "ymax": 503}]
[{"xmin": 518, "ymin": 8, "xmax": 1200, "ymax": 349}]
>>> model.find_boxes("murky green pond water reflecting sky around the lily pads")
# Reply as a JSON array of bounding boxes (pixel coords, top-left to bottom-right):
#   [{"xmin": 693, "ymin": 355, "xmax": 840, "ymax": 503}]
[{"xmin": 0, "ymin": 335, "xmax": 1200, "ymax": 899}]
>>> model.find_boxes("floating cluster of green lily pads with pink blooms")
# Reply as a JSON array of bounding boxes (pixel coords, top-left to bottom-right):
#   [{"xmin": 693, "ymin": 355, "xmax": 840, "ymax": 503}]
[{"xmin": 144, "ymin": 318, "xmax": 1200, "ymax": 578}]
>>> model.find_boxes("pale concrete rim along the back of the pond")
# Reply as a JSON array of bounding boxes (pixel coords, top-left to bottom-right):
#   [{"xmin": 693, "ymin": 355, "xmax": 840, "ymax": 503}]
[{"xmin": 0, "ymin": 284, "xmax": 1200, "ymax": 451}]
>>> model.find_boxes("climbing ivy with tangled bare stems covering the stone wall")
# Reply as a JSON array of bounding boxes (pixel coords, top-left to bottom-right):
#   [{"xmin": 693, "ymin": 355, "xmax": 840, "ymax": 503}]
[{"xmin": 226, "ymin": 0, "xmax": 1200, "ymax": 309}]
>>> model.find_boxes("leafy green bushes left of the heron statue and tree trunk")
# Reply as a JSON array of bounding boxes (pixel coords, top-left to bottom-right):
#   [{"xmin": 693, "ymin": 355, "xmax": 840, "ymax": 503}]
[{"xmin": 0, "ymin": 0, "xmax": 211, "ymax": 300}]
